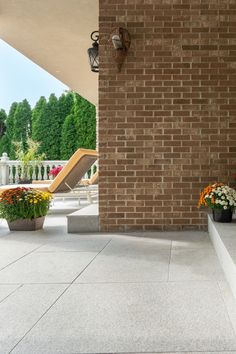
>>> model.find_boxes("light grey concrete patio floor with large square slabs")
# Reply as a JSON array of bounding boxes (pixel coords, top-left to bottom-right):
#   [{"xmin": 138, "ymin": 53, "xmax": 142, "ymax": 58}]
[{"xmin": 0, "ymin": 214, "xmax": 236, "ymax": 354}]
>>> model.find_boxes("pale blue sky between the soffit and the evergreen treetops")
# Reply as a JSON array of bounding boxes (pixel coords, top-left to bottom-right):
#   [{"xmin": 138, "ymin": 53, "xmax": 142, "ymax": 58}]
[{"xmin": 0, "ymin": 39, "xmax": 68, "ymax": 112}]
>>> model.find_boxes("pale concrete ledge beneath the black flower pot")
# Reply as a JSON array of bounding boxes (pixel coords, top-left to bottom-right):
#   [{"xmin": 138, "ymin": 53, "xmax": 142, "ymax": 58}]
[{"xmin": 208, "ymin": 215, "xmax": 236, "ymax": 298}]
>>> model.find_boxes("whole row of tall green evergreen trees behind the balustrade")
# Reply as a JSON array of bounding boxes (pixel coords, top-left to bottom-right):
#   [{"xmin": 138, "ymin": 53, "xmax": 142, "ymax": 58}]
[{"xmin": 0, "ymin": 91, "xmax": 96, "ymax": 160}]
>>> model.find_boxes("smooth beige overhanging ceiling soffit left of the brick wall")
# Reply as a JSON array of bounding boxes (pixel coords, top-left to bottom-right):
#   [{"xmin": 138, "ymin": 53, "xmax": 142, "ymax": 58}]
[{"xmin": 0, "ymin": 0, "xmax": 98, "ymax": 104}]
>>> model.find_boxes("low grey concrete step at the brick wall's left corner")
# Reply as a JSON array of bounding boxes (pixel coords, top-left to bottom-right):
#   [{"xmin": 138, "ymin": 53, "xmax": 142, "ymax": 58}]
[{"xmin": 67, "ymin": 204, "xmax": 99, "ymax": 233}]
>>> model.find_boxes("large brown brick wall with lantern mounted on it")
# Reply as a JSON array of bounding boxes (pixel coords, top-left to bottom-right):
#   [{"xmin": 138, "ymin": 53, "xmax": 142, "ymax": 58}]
[{"xmin": 99, "ymin": 0, "xmax": 236, "ymax": 231}]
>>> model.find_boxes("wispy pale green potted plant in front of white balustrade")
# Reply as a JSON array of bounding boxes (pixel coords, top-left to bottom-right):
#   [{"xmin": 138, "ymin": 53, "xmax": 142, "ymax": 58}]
[{"xmin": 14, "ymin": 138, "xmax": 45, "ymax": 184}]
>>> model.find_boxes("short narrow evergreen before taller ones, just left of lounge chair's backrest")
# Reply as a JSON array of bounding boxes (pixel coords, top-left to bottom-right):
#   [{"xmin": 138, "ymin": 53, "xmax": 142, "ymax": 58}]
[{"xmin": 61, "ymin": 114, "xmax": 78, "ymax": 160}]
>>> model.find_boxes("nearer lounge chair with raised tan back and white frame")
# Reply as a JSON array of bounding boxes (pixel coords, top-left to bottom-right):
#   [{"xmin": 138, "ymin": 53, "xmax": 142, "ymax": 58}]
[{"xmin": 0, "ymin": 149, "xmax": 98, "ymax": 201}]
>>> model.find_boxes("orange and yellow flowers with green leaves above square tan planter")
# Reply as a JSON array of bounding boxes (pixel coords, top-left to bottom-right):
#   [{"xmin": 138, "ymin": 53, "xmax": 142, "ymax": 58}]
[{"xmin": 0, "ymin": 187, "xmax": 51, "ymax": 221}]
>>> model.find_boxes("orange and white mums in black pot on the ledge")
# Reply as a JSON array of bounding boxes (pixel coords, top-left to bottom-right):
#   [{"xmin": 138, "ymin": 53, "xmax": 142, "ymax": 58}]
[{"xmin": 198, "ymin": 183, "xmax": 236, "ymax": 222}]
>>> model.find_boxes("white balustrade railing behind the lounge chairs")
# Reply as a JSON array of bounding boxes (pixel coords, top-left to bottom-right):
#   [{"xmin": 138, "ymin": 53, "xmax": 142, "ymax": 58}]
[{"xmin": 0, "ymin": 153, "xmax": 98, "ymax": 185}]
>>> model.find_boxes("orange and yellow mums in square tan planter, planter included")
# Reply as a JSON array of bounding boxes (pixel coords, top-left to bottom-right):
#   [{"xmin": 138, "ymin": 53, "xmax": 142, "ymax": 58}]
[{"xmin": 0, "ymin": 187, "xmax": 52, "ymax": 231}]
